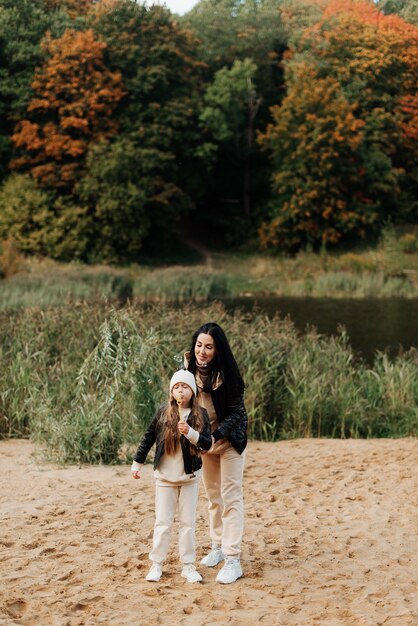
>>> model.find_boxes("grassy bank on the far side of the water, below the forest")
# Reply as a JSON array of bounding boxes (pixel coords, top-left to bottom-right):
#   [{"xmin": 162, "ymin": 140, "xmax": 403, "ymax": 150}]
[{"xmin": 0, "ymin": 225, "xmax": 418, "ymax": 308}]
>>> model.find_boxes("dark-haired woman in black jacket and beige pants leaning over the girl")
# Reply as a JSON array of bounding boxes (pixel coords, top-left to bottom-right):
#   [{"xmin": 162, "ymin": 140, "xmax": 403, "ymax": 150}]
[{"xmin": 186, "ymin": 322, "xmax": 248, "ymax": 584}]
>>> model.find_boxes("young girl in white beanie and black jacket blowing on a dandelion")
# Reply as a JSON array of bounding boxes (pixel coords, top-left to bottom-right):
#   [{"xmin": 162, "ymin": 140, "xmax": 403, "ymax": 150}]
[{"xmin": 131, "ymin": 370, "xmax": 211, "ymax": 583}]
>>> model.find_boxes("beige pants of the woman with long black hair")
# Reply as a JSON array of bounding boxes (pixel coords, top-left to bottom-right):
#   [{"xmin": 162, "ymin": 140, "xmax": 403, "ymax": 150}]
[{"xmin": 202, "ymin": 446, "xmax": 245, "ymax": 558}]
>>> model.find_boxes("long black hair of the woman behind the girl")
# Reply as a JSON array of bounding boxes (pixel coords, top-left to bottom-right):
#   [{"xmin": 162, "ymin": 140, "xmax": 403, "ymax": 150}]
[{"xmin": 188, "ymin": 322, "xmax": 244, "ymax": 393}]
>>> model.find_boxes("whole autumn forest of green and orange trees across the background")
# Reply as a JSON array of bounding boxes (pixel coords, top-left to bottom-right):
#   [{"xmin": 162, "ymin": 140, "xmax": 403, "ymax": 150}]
[{"xmin": 0, "ymin": 0, "xmax": 418, "ymax": 264}]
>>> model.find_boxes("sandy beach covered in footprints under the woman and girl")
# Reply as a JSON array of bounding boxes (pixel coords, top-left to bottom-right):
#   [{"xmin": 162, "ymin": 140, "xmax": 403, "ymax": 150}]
[{"xmin": 0, "ymin": 439, "xmax": 418, "ymax": 626}]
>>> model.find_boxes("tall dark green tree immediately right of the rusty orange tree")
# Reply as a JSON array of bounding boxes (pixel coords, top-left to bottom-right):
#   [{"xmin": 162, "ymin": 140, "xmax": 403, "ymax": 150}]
[{"xmin": 91, "ymin": 0, "xmax": 201, "ymax": 236}]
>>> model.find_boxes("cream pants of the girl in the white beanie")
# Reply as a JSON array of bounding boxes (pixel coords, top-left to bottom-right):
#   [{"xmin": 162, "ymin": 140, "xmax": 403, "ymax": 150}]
[{"xmin": 149, "ymin": 479, "xmax": 199, "ymax": 563}]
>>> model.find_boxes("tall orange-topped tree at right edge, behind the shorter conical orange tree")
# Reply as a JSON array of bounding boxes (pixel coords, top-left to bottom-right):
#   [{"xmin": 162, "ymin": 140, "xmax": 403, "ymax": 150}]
[{"xmin": 301, "ymin": 0, "xmax": 418, "ymax": 221}]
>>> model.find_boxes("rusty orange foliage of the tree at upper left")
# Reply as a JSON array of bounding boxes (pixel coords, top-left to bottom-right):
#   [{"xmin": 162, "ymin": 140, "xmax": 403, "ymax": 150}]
[{"xmin": 12, "ymin": 30, "xmax": 124, "ymax": 188}]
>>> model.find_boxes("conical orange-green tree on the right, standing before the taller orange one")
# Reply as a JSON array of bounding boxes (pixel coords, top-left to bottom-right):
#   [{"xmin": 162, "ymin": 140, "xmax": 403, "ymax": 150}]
[{"xmin": 259, "ymin": 64, "xmax": 377, "ymax": 250}]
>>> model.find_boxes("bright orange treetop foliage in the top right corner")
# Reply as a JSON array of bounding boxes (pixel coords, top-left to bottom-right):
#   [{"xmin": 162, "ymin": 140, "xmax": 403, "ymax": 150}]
[{"xmin": 302, "ymin": 0, "xmax": 418, "ymax": 118}]
